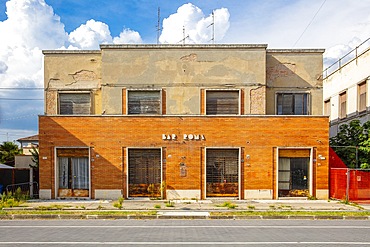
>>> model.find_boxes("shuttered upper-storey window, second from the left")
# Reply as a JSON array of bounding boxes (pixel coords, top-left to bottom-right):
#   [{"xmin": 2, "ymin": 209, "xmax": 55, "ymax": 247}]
[{"xmin": 128, "ymin": 90, "xmax": 161, "ymax": 114}]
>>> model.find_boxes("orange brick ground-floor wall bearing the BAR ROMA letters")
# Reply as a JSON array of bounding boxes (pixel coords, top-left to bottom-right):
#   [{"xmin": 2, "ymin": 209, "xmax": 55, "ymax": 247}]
[{"xmin": 39, "ymin": 116, "xmax": 329, "ymax": 198}]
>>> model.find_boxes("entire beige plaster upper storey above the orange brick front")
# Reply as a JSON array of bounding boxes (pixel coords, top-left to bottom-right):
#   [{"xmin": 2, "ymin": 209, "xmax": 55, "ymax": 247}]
[{"xmin": 44, "ymin": 44, "xmax": 324, "ymax": 115}]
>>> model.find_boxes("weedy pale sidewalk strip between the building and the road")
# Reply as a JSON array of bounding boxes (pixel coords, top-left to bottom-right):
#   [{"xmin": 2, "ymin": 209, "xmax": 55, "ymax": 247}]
[{"xmin": 0, "ymin": 199, "xmax": 370, "ymax": 220}]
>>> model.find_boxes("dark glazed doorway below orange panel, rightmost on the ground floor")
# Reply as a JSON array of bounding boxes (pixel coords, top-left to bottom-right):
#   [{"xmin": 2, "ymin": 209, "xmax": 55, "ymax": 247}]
[{"xmin": 279, "ymin": 158, "xmax": 310, "ymax": 197}]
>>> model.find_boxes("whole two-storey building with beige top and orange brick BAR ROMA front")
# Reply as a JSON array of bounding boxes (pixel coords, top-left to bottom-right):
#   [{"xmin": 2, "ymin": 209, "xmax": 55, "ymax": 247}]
[{"xmin": 39, "ymin": 45, "xmax": 329, "ymax": 199}]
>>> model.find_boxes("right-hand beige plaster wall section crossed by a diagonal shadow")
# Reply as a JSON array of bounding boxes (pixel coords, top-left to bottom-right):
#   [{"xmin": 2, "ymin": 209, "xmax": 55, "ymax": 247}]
[{"xmin": 266, "ymin": 49, "xmax": 324, "ymax": 115}]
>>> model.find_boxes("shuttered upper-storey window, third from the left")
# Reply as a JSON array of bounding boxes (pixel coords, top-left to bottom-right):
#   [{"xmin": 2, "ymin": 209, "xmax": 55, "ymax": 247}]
[{"xmin": 206, "ymin": 90, "xmax": 239, "ymax": 115}]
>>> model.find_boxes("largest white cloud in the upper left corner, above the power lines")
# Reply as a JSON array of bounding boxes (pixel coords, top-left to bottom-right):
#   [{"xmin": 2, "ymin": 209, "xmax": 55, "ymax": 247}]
[{"xmin": 0, "ymin": 0, "xmax": 67, "ymax": 91}]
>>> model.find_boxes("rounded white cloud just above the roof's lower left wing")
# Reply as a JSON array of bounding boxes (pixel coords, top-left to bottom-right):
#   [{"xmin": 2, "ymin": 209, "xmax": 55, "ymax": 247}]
[{"xmin": 69, "ymin": 20, "xmax": 112, "ymax": 50}]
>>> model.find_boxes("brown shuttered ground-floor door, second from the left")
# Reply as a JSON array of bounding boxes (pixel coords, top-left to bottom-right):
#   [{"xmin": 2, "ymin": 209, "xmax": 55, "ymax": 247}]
[{"xmin": 128, "ymin": 149, "xmax": 161, "ymax": 197}]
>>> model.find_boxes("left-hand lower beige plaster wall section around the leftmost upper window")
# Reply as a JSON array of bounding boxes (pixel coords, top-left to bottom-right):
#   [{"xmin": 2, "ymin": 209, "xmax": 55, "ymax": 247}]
[{"xmin": 44, "ymin": 51, "xmax": 101, "ymax": 115}]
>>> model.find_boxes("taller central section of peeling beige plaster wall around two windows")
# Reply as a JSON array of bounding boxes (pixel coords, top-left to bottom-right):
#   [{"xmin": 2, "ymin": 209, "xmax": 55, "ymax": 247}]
[{"xmin": 102, "ymin": 45, "xmax": 266, "ymax": 115}]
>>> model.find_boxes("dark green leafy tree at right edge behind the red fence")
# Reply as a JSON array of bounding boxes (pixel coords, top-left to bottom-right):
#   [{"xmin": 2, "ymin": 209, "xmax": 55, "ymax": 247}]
[{"xmin": 330, "ymin": 120, "xmax": 370, "ymax": 168}]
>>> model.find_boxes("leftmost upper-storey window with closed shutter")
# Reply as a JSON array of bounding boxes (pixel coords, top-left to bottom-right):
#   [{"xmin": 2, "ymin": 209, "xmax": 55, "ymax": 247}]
[{"xmin": 59, "ymin": 93, "xmax": 91, "ymax": 115}]
